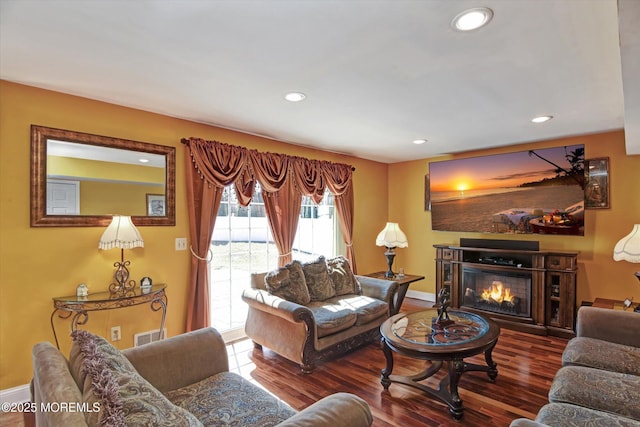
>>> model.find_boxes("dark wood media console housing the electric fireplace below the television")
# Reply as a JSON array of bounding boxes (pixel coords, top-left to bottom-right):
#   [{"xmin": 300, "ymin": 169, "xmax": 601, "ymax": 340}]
[{"xmin": 434, "ymin": 239, "xmax": 578, "ymax": 338}]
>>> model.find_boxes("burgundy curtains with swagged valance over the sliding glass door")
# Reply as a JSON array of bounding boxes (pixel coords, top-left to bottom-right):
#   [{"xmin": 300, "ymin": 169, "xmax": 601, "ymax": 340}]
[{"xmin": 182, "ymin": 138, "xmax": 356, "ymax": 331}]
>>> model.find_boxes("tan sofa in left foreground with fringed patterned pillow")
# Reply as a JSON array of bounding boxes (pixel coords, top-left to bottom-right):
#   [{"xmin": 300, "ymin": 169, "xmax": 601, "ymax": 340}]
[{"xmin": 31, "ymin": 328, "xmax": 372, "ymax": 427}]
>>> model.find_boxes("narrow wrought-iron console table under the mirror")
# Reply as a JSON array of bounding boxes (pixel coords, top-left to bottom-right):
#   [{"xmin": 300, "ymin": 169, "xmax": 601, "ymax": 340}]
[{"xmin": 51, "ymin": 285, "xmax": 167, "ymax": 349}]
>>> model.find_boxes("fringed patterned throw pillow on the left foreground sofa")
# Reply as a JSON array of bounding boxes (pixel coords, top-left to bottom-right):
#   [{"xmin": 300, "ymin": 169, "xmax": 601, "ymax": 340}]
[{"xmin": 72, "ymin": 330, "xmax": 202, "ymax": 426}]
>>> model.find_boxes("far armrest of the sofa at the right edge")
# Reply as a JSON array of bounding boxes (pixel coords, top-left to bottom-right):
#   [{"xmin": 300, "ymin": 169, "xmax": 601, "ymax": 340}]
[{"xmin": 576, "ymin": 306, "xmax": 640, "ymax": 347}]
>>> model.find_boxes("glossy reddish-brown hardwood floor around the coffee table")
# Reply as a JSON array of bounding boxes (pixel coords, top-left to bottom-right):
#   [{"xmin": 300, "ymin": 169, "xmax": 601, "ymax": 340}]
[{"xmin": 229, "ymin": 299, "xmax": 567, "ymax": 427}]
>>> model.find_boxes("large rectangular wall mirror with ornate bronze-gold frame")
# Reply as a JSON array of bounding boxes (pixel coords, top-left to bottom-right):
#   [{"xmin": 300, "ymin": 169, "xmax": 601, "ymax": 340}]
[{"xmin": 31, "ymin": 125, "xmax": 176, "ymax": 227}]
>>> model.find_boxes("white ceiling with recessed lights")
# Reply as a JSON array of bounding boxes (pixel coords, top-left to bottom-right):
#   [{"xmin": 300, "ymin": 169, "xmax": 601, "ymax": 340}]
[{"xmin": 0, "ymin": 0, "xmax": 640, "ymax": 163}]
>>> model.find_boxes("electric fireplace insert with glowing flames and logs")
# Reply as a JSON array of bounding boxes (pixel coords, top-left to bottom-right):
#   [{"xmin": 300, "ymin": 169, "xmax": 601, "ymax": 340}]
[{"xmin": 462, "ymin": 266, "xmax": 532, "ymax": 318}]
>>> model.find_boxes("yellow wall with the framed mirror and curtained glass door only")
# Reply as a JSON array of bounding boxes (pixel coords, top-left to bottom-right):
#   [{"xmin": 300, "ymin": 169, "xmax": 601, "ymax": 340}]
[{"xmin": 0, "ymin": 81, "xmax": 387, "ymax": 390}]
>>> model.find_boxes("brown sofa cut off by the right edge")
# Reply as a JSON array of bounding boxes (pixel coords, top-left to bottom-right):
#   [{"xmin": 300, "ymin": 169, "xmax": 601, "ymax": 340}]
[{"xmin": 511, "ymin": 306, "xmax": 640, "ymax": 427}]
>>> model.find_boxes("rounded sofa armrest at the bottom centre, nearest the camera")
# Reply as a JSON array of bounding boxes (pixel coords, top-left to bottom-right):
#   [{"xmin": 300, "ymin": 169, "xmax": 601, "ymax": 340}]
[{"xmin": 278, "ymin": 393, "xmax": 373, "ymax": 427}]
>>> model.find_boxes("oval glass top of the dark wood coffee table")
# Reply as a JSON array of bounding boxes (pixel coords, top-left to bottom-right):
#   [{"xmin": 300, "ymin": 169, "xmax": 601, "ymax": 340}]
[{"xmin": 391, "ymin": 309, "xmax": 489, "ymax": 346}]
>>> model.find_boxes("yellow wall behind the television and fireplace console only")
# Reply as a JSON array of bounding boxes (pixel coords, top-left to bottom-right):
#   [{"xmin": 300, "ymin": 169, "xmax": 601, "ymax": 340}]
[{"xmin": 389, "ymin": 131, "xmax": 640, "ymax": 305}]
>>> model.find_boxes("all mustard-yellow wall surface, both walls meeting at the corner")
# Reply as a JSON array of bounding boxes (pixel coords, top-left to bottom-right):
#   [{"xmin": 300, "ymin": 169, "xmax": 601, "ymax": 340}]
[{"xmin": 0, "ymin": 81, "xmax": 640, "ymax": 389}]
